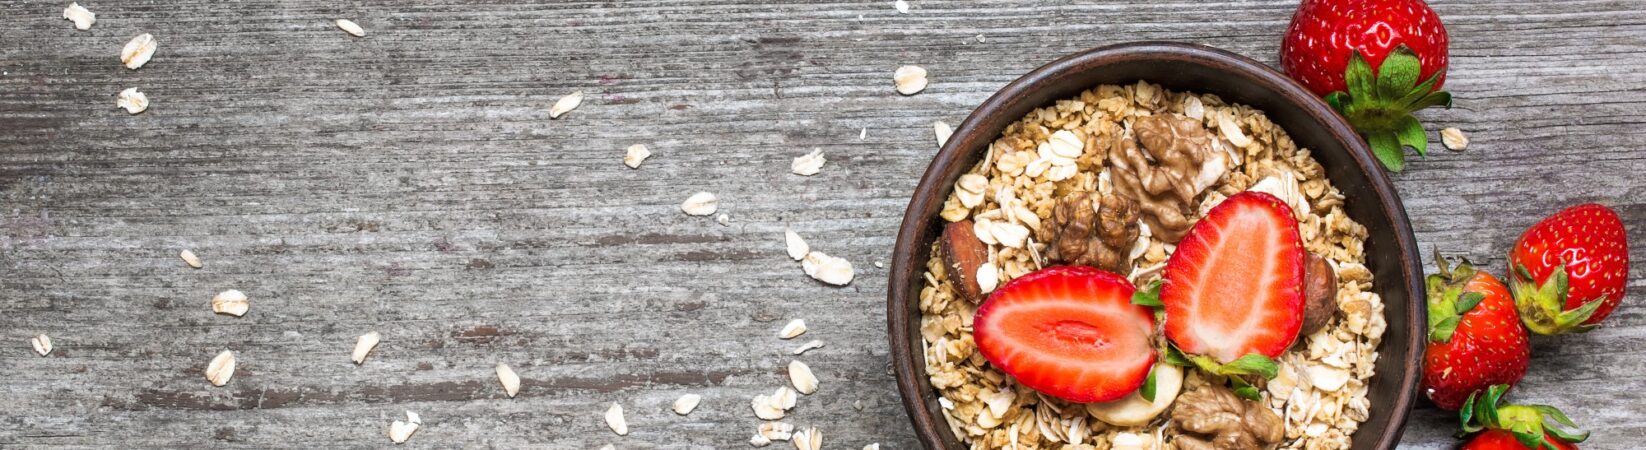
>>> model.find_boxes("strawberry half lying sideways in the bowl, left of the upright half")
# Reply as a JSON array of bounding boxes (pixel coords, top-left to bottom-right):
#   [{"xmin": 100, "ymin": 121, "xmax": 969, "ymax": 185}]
[{"xmin": 973, "ymin": 265, "xmax": 1155, "ymax": 402}]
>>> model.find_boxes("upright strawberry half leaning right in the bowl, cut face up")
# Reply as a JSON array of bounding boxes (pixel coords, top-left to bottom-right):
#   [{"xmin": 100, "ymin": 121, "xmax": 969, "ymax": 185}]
[{"xmin": 1160, "ymin": 191, "xmax": 1304, "ymax": 364}]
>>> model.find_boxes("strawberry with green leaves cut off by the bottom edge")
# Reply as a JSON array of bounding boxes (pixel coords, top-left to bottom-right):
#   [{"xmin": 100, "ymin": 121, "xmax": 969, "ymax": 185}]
[{"xmin": 1458, "ymin": 384, "xmax": 1588, "ymax": 450}]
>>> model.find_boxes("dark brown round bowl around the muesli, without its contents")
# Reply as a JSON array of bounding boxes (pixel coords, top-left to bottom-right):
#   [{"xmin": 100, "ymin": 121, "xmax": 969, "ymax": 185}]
[{"xmin": 886, "ymin": 43, "xmax": 1427, "ymax": 450}]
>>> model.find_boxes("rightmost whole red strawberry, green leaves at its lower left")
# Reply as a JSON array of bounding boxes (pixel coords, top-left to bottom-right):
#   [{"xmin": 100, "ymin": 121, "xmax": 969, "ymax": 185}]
[{"xmin": 1509, "ymin": 203, "xmax": 1630, "ymax": 335}]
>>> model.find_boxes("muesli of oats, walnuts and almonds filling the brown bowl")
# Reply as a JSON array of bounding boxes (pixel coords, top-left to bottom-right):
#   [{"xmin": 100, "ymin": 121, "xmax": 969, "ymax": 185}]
[{"xmin": 920, "ymin": 82, "xmax": 1386, "ymax": 450}]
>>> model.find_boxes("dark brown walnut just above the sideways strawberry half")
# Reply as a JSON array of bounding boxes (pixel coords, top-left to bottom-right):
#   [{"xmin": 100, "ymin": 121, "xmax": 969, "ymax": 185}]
[{"xmin": 1040, "ymin": 191, "xmax": 1137, "ymax": 274}]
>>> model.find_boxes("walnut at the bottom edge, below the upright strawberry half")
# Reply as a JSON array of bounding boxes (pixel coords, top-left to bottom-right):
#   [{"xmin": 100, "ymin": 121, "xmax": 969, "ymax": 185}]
[{"xmin": 1172, "ymin": 384, "xmax": 1286, "ymax": 450}]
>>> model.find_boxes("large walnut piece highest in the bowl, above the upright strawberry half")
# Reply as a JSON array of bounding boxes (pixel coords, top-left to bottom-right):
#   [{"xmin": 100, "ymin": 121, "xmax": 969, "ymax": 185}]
[{"xmin": 1108, "ymin": 114, "xmax": 1228, "ymax": 244}]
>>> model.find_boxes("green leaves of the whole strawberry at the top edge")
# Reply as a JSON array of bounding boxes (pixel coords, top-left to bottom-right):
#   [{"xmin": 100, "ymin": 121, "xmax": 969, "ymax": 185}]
[{"xmin": 1325, "ymin": 46, "xmax": 1452, "ymax": 171}]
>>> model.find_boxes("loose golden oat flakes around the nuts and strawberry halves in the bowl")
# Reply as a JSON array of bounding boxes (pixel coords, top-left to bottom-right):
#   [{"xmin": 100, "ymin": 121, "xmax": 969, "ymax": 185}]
[{"xmin": 920, "ymin": 82, "xmax": 1388, "ymax": 450}]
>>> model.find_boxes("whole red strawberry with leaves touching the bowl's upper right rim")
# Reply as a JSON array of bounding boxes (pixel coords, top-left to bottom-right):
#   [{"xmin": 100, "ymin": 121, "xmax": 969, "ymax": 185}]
[{"xmin": 1281, "ymin": 0, "xmax": 1452, "ymax": 171}]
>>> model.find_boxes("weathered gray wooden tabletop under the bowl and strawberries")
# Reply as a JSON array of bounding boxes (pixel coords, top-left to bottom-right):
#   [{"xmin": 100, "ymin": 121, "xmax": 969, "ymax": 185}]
[{"xmin": 0, "ymin": 0, "xmax": 1646, "ymax": 448}]
